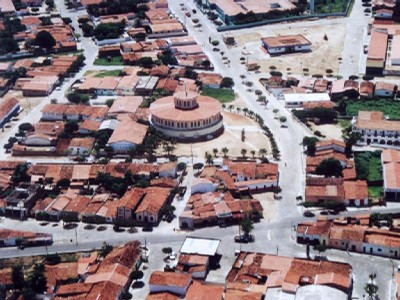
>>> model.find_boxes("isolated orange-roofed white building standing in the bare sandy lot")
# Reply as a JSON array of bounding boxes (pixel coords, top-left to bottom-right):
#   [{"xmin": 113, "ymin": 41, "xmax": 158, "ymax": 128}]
[{"xmin": 261, "ymin": 34, "xmax": 312, "ymax": 55}]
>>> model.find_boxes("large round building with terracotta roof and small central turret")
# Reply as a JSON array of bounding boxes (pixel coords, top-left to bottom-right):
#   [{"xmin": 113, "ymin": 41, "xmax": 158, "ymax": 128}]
[{"xmin": 150, "ymin": 91, "xmax": 224, "ymax": 140}]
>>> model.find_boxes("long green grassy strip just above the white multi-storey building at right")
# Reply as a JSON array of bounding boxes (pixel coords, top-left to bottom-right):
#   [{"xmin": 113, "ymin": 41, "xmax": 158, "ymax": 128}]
[{"xmin": 346, "ymin": 99, "xmax": 400, "ymax": 119}]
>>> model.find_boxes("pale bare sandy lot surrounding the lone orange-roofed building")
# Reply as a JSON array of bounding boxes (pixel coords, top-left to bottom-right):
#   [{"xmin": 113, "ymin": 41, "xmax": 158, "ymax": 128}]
[{"xmin": 233, "ymin": 24, "xmax": 347, "ymax": 75}]
